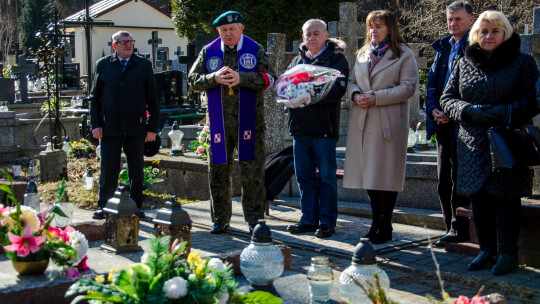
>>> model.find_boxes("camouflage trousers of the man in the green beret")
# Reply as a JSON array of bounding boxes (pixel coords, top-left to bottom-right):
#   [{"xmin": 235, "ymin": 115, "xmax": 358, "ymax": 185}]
[{"xmin": 208, "ymin": 130, "xmax": 266, "ymax": 224}]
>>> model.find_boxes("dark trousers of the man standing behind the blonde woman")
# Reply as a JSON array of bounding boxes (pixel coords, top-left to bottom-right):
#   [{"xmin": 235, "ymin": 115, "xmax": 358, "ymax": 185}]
[{"xmin": 436, "ymin": 121, "xmax": 469, "ymax": 235}]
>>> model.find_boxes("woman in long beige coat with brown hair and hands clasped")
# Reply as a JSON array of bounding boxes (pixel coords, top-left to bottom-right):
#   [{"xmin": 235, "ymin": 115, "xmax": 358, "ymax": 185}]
[{"xmin": 343, "ymin": 10, "xmax": 418, "ymax": 244}]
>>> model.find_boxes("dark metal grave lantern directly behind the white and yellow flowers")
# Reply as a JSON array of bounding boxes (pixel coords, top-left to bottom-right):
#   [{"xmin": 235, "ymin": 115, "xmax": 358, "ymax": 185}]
[{"xmin": 152, "ymin": 195, "xmax": 192, "ymax": 257}]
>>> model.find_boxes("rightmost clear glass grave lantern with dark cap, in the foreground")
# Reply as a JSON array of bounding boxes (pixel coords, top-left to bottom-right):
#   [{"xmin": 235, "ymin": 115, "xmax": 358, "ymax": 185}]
[{"xmin": 339, "ymin": 238, "xmax": 390, "ymax": 303}]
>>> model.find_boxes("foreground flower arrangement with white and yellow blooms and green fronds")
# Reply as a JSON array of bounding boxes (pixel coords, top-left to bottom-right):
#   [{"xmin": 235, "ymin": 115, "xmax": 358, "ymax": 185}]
[{"xmin": 66, "ymin": 236, "xmax": 282, "ymax": 304}]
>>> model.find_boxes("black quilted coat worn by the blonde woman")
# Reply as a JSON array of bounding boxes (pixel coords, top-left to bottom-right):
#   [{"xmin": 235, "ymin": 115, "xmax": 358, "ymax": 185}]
[{"xmin": 441, "ymin": 33, "xmax": 539, "ymax": 199}]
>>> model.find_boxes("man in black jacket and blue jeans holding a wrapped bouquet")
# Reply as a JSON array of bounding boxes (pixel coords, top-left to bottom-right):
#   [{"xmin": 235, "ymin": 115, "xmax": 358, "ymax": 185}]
[{"xmin": 287, "ymin": 19, "xmax": 349, "ymax": 237}]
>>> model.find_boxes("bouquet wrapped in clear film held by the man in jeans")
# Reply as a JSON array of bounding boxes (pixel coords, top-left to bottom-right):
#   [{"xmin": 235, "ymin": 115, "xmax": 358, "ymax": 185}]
[{"xmin": 274, "ymin": 64, "xmax": 344, "ymax": 108}]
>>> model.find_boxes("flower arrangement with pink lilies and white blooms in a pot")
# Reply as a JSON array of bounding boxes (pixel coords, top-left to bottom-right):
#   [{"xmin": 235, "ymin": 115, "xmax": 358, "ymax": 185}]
[{"xmin": 0, "ymin": 169, "xmax": 89, "ymax": 277}]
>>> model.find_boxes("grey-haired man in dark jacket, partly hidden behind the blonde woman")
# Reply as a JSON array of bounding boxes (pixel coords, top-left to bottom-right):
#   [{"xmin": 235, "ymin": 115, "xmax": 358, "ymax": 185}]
[{"xmin": 426, "ymin": 0, "xmax": 474, "ymax": 247}]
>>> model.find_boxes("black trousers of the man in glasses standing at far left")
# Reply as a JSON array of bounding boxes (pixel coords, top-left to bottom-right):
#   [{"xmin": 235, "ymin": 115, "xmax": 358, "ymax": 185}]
[{"xmin": 98, "ymin": 136, "xmax": 144, "ymax": 209}]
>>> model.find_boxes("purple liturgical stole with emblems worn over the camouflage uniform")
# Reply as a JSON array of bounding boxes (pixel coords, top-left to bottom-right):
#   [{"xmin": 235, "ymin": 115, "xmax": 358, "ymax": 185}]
[{"xmin": 206, "ymin": 35, "xmax": 258, "ymax": 164}]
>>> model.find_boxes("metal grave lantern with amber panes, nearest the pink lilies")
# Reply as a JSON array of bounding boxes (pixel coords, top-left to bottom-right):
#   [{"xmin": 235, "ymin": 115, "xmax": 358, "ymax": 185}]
[{"xmin": 101, "ymin": 186, "xmax": 142, "ymax": 254}]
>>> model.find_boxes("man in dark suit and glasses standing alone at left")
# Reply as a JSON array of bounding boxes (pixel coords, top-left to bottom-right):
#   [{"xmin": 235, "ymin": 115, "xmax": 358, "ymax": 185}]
[{"xmin": 90, "ymin": 31, "xmax": 159, "ymax": 219}]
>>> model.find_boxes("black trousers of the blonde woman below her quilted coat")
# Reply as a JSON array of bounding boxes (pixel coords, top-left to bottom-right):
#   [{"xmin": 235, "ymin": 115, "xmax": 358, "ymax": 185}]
[{"xmin": 471, "ymin": 189, "xmax": 521, "ymax": 255}]
